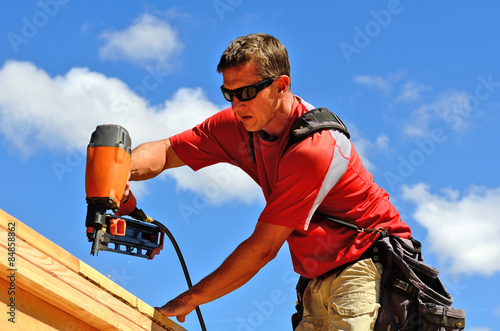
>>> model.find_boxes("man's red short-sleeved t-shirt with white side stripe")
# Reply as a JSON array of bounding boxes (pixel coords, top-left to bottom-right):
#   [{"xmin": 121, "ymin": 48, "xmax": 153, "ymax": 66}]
[{"xmin": 170, "ymin": 97, "xmax": 410, "ymax": 278}]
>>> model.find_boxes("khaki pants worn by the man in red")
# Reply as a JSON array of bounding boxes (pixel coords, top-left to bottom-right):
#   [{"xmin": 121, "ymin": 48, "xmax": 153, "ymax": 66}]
[{"xmin": 296, "ymin": 259, "xmax": 382, "ymax": 331}]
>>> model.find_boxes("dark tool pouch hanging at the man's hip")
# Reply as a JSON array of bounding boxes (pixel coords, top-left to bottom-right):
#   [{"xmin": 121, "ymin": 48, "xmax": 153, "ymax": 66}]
[{"xmin": 367, "ymin": 235, "xmax": 465, "ymax": 331}]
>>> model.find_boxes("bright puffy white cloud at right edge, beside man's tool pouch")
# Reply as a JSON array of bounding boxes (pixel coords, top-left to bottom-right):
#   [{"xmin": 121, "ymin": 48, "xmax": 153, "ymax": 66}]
[{"xmin": 403, "ymin": 184, "xmax": 500, "ymax": 275}]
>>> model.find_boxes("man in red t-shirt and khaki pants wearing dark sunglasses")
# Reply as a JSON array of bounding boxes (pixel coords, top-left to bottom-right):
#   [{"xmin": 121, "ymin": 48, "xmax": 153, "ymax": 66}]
[{"xmin": 131, "ymin": 34, "xmax": 410, "ymax": 331}]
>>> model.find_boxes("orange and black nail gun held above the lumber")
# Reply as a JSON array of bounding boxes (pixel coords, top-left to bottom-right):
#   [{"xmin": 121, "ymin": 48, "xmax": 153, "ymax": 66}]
[{"xmin": 85, "ymin": 124, "xmax": 164, "ymax": 259}]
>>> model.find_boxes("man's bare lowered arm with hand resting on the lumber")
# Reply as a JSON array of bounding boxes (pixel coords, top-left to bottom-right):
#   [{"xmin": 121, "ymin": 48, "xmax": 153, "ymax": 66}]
[{"xmin": 158, "ymin": 222, "xmax": 294, "ymax": 322}]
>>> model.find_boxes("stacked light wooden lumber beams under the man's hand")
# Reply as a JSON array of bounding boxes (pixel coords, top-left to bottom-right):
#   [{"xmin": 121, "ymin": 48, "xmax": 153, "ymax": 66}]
[{"xmin": 0, "ymin": 209, "xmax": 185, "ymax": 331}]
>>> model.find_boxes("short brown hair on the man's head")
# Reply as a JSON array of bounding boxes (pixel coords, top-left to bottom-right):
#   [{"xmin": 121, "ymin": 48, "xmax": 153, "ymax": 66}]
[{"xmin": 217, "ymin": 33, "xmax": 291, "ymax": 85}]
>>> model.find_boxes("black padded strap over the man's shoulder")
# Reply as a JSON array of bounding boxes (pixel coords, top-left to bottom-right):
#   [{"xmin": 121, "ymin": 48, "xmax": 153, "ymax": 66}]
[{"xmin": 285, "ymin": 107, "xmax": 351, "ymax": 151}]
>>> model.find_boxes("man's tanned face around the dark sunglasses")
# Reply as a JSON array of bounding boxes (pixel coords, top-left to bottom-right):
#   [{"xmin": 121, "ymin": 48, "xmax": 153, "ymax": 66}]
[{"xmin": 222, "ymin": 61, "xmax": 278, "ymax": 134}]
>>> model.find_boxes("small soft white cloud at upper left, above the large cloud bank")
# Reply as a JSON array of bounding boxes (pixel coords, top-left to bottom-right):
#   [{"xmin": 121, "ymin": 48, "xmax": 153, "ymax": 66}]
[{"xmin": 99, "ymin": 13, "xmax": 183, "ymax": 67}]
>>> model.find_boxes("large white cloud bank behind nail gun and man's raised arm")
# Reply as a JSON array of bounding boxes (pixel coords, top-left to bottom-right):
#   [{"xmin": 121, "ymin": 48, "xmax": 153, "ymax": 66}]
[{"xmin": 0, "ymin": 61, "xmax": 261, "ymax": 203}]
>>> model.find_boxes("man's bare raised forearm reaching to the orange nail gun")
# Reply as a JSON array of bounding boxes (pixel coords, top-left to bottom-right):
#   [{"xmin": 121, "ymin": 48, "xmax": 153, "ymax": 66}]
[{"xmin": 130, "ymin": 139, "xmax": 185, "ymax": 180}]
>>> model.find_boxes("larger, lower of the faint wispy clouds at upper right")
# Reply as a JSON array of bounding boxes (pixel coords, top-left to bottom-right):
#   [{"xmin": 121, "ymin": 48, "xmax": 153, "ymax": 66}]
[{"xmin": 404, "ymin": 90, "xmax": 472, "ymax": 137}]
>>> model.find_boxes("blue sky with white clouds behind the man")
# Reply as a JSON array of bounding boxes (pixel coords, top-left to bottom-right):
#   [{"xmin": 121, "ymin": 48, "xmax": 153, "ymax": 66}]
[{"xmin": 0, "ymin": 0, "xmax": 500, "ymax": 331}]
